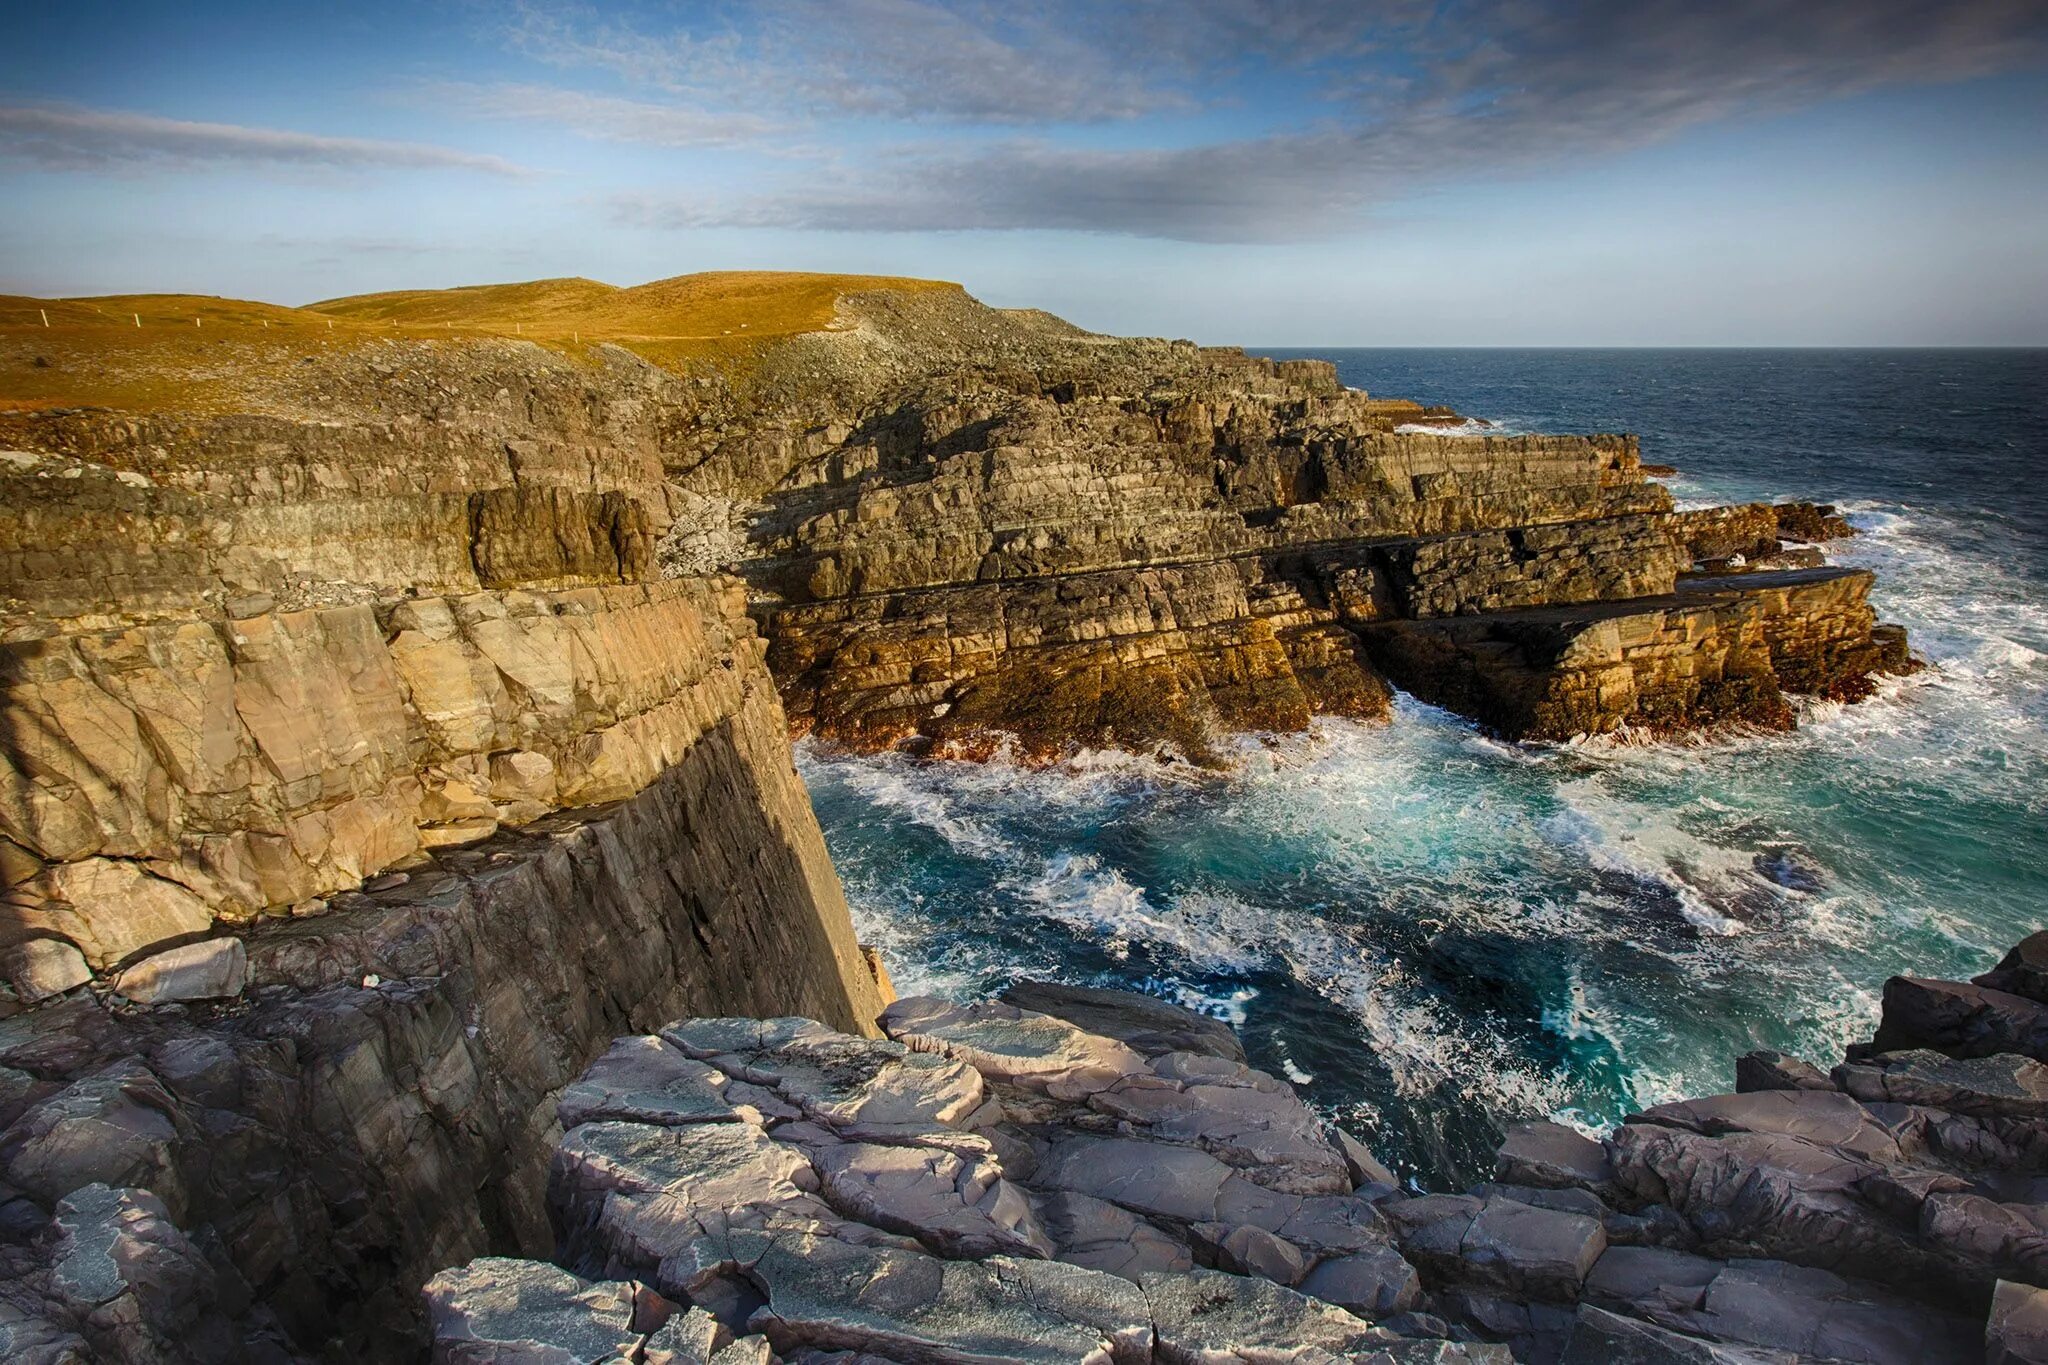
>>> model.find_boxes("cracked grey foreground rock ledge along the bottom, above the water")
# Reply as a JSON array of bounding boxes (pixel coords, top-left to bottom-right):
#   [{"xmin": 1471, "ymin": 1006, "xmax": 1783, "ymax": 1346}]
[{"xmin": 403, "ymin": 933, "xmax": 2048, "ymax": 1365}]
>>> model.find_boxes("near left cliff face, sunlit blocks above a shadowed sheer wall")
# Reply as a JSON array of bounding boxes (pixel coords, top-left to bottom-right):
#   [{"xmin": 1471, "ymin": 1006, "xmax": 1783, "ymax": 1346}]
[{"xmin": 0, "ymin": 290, "xmax": 885, "ymax": 1359}]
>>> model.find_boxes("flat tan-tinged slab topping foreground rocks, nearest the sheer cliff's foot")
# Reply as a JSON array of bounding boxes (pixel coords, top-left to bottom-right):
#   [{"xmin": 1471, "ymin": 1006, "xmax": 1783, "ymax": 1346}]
[{"xmin": 881, "ymin": 995, "xmax": 1149, "ymax": 1099}]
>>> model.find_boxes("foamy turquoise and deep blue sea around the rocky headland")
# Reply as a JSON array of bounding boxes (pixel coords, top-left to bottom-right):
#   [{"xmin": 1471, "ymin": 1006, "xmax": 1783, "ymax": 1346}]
[{"xmin": 799, "ymin": 350, "xmax": 2048, "ymax": 1187}]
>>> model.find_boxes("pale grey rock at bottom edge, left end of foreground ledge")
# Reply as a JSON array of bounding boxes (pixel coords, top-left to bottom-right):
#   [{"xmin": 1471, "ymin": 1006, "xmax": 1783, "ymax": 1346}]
[{"xmin": 424, "ymin": 1257, "xmax": 634, "ymax": 1365}]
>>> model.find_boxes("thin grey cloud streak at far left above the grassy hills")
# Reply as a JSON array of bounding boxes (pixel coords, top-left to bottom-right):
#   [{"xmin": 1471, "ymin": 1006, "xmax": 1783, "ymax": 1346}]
[{"xmin": 0, "ymin": 104, "xmax": 528, "ymax": 176}]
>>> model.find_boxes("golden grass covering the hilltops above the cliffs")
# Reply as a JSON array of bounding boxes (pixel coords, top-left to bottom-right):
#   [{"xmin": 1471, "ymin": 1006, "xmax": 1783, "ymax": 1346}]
[{"xmin": 0, "ymin": 270, "xmax": 958, "ymax": 411}]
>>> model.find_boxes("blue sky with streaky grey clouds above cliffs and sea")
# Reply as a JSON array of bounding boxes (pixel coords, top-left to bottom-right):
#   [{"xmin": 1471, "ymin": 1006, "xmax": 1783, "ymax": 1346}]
[{"xmin": 0, "ymin": 0, "xmax": 2048, "ymax": 346}]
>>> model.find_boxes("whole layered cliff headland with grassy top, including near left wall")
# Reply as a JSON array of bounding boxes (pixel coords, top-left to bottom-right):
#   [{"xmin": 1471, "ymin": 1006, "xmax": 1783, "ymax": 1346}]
[{"xmin": 0, "ymin": 274, "xmax": 1907, "ymax": 1359}]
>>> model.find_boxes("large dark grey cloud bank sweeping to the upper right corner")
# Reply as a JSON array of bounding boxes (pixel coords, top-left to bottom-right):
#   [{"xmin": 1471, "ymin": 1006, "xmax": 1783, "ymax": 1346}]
[{"xmin": 614, "ymin": 0, "xmax": 2048, "ymax": 241}]
